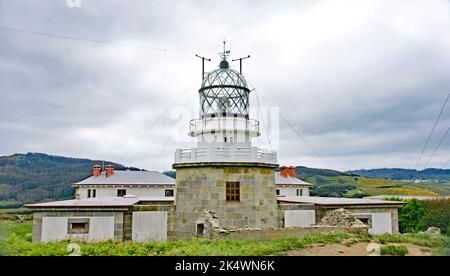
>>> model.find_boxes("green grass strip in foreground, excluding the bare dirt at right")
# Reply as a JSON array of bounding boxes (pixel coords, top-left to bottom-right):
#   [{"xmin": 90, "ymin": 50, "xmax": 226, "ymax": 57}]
[{"xmin": 0, "ymin": 229, "xmax": 355, "ymax": 256}]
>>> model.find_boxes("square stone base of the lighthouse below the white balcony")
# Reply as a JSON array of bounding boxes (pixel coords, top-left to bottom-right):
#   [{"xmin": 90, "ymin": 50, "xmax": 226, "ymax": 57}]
[{"xmin": 173, "ymin": 163, "xmax": 281, "ymax": 238}]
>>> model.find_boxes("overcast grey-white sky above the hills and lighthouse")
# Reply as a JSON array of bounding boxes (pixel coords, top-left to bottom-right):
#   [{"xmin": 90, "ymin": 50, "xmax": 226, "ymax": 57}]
[{"xmin": 0, "ymin": 0, "xmax": 450, "ymax": 170}]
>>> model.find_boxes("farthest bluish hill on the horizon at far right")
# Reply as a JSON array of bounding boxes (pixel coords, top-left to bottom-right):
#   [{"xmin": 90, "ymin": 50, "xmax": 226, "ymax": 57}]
[{"xmin": 346, "ymin": 168, "xmax": 450, "ymax": 181}]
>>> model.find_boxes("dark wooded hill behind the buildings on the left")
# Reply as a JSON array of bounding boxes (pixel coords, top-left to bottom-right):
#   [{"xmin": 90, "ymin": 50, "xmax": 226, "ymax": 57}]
[{"xmin": 0, "ymin": 153, "xmax": 139, "ymax": 208}]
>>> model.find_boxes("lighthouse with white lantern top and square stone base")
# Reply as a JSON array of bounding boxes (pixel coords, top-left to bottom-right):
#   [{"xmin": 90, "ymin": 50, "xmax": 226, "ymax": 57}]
[{"xmin": 173, "ymin": 44, "xmax": 279, "ymax": 237}]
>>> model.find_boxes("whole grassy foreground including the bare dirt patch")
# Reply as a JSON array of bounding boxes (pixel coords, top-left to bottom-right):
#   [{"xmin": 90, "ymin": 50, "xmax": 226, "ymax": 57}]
[{"xmin": 0, "ymin": 221, "xmax": 450, "ymax": 256}]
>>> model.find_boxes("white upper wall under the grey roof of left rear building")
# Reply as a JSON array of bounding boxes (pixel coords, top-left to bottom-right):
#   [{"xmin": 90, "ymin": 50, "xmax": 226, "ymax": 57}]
[{"xmin": 78, "ymin": 187, "xmax": 175, "ymax": 198}]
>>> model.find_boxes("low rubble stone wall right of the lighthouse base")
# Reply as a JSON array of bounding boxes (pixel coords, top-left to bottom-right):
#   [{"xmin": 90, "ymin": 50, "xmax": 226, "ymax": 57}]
[{"xmin": 226, "ymin": 226, "xmax": 367, "ymax": 240}]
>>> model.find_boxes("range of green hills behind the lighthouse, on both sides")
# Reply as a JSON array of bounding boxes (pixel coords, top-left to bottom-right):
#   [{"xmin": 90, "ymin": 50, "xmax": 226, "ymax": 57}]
[{"xmin": 0, "ymin": 153, "xmax": 450, "ymax": 209}]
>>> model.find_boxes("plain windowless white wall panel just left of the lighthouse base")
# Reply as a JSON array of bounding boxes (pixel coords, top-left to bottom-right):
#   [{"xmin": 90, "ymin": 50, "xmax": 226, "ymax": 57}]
[{"xmin": 131, "ymin": 211, "xmax": 167, "ymax": 242}]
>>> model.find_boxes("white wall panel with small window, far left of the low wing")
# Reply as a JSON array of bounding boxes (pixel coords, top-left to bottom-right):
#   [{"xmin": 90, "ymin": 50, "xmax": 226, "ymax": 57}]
[{"xmin": 41, "ymin": 217, "xmax": 114, "ymax": 242}]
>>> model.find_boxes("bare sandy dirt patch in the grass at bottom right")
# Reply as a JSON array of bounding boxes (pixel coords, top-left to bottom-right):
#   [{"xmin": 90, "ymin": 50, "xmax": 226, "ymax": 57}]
[{"xmin": 288, "ymin": 242, "xmax": 431, "ymax": 256}]
